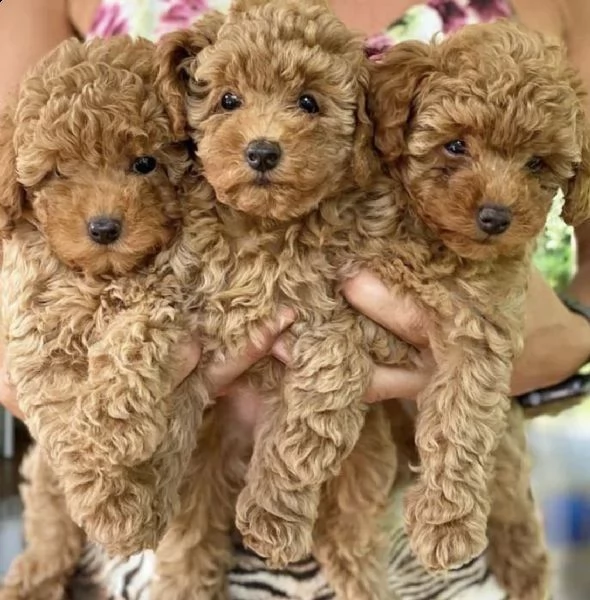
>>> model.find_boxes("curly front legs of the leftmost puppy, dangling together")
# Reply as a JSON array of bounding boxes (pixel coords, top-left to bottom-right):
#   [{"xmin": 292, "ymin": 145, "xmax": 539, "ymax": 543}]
[{"xmin": 60, "ymin": 298, "xmax": 207, "ymax": 555}]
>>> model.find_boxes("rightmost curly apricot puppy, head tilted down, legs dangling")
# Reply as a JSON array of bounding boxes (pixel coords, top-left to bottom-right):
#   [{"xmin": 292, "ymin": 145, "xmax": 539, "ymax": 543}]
[{"xmin": 368, "ymin": 22, "xmax": 590, "ymax": 600}]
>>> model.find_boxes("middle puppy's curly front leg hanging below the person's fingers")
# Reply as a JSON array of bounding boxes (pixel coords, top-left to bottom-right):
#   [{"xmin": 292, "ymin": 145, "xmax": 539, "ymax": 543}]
[{"xmin": 237, "ymin": 315, "xmax": 372, "ymax": 566}]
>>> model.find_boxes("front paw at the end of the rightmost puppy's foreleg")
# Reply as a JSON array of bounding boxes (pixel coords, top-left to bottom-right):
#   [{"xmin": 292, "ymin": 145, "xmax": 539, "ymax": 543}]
[{"xmin": 406, "ymin": 484, "xmax": 488, "ymax": 571}]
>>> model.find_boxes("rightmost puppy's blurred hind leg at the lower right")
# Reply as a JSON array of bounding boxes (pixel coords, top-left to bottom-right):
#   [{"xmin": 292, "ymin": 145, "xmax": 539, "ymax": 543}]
[{"xmin": 488, "ymin": 403, "xmax": 549, "ymax": 600}]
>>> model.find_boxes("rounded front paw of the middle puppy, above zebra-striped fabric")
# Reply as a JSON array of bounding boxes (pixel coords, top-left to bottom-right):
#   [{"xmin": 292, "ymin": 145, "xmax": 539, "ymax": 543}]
[{"xmin": 236, "ymin": 493, "xmax": 312, "ymax": 569}]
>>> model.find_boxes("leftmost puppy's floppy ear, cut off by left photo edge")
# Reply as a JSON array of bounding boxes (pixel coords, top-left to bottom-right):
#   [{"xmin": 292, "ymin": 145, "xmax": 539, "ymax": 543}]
[{"xmin": 0, "ymin": 106, "xmax": 26, "ymax": 238}]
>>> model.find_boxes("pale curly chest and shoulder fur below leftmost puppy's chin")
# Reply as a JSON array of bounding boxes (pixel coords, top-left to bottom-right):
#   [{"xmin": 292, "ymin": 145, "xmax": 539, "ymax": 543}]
[{"xmin": 2, "ymin": 229, "xmax": 192, "ymax": 408}]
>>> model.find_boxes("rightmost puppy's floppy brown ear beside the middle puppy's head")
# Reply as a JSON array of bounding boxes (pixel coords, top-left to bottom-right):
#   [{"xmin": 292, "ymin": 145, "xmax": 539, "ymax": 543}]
[{"xmin": 369, "ymin": 41, "xmax": 434, "ymax": 163}]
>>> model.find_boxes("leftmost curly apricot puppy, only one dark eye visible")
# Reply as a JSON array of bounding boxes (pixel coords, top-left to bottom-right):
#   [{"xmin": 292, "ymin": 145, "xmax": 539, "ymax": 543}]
[{"xmin": 0, "ymin": 38, "xmax": 207, "ymax": 560}]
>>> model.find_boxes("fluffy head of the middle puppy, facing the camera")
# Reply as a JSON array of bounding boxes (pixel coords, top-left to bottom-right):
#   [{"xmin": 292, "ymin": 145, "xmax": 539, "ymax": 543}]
[{"xmin": 155, "ymin": 0, "xmax": 372, "ymax": 221}]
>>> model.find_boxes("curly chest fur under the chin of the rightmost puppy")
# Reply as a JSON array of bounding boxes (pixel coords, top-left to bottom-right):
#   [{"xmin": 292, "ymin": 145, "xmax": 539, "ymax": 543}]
[{"xmin": 346, "ymin": 207, "xmax": 533, "ymax": 345}]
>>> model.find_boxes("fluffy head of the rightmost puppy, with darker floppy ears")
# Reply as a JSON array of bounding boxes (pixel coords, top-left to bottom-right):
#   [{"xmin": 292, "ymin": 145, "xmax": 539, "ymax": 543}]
[{"xmin": 369, "ymin": 21, "xmax": 590, "ymax": 259}]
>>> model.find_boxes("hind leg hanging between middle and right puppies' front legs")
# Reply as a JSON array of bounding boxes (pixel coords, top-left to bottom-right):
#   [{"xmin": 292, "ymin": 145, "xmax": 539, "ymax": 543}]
[{"xmin": 314, "ymin": 406, "xmax": 397, "ymax": 600}]
